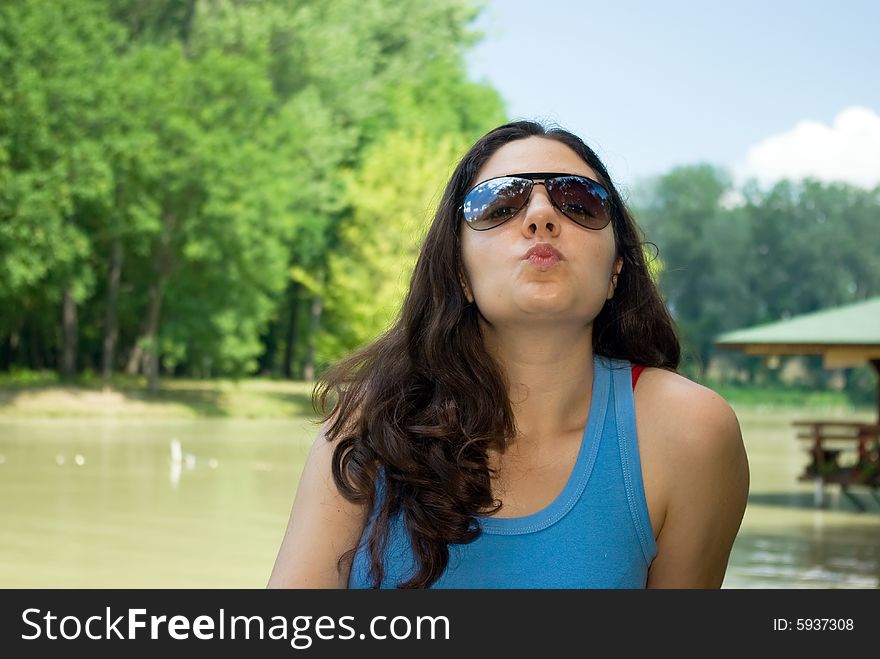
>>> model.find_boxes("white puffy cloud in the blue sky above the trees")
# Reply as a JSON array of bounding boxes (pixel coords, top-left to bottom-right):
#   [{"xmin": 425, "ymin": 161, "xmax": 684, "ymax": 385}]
[{"xmin": 734, "ymin": 106, "xmax": 880, "ymax": 187}]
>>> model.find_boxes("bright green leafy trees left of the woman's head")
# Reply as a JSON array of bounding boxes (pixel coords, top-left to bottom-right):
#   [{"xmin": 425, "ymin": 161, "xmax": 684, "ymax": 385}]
[{"xmin": 0, "ymin": 0, "xmax": 503, "ymax": 376}]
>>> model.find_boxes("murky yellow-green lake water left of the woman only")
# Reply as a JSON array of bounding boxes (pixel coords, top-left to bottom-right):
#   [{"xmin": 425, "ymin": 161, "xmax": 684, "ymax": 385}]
[{"xmin": 0, "ymin": 419, "xmax": 315, "ymax": 588}]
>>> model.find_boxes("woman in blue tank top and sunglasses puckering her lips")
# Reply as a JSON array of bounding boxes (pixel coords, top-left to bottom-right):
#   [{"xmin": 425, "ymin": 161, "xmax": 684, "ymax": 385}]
[{"xmin": 269, "ymin": 122, "xmax": 749, "ymax": 588}]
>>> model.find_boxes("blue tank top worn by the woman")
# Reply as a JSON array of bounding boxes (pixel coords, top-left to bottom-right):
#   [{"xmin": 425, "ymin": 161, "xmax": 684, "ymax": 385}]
[{"xmin": 348, "ymin": 355, "xmax": 657, "ymax": 588}]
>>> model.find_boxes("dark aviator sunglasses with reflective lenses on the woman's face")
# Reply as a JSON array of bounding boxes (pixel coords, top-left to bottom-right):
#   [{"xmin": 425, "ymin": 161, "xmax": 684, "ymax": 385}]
[{"xmin": 461, "ymin": 172, "xmax": 611, "ymax": 231}]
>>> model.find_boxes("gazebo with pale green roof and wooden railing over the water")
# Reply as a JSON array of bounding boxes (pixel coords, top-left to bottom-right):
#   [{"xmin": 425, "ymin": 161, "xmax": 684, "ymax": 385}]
[{"xmin": 715, "ymin": 297, "xmax": 880, "ymax": 507}]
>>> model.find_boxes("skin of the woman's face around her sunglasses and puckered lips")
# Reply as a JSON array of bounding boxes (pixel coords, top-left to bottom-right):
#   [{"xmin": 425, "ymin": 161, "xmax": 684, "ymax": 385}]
[{"xmin": 461, "ymin": 137, "xmax": 623, "ymax": 327}]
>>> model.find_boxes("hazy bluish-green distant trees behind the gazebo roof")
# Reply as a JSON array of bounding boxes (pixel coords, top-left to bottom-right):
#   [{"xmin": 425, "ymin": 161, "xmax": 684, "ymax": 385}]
[{"xmin": 632, "ymin": 164, "xmax": 880, "ymax": 402}]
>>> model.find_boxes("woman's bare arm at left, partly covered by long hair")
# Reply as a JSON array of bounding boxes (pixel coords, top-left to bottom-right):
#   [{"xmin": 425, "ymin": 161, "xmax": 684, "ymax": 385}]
[{"xmin": 267, "ymin": 427, "xmax": 366, "ymax": 588}]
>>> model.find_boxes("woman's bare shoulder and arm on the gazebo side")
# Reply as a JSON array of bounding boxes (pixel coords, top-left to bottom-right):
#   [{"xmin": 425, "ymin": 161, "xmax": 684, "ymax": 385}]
[{"xmin": 636, "ymin": 368, "xmax": 749, "ymax": 588}]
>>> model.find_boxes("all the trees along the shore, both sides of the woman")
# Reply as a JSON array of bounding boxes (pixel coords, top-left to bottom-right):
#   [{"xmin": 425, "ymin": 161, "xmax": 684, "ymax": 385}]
[{"xmin": 0, "ymin": 0, "xmax": 880, "ymax": 402}]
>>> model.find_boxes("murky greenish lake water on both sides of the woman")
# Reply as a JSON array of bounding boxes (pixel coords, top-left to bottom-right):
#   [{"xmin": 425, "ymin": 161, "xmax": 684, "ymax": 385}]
[{"xmin": 0, "ymin": 408, "xmax": 880, "ymax": 588}]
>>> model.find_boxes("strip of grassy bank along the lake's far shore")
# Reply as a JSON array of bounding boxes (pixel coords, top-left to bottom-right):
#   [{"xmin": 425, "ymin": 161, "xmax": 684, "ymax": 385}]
[{"xmin": 0, "ymin": 372, "xmax": 872, "ymax": 418}]
